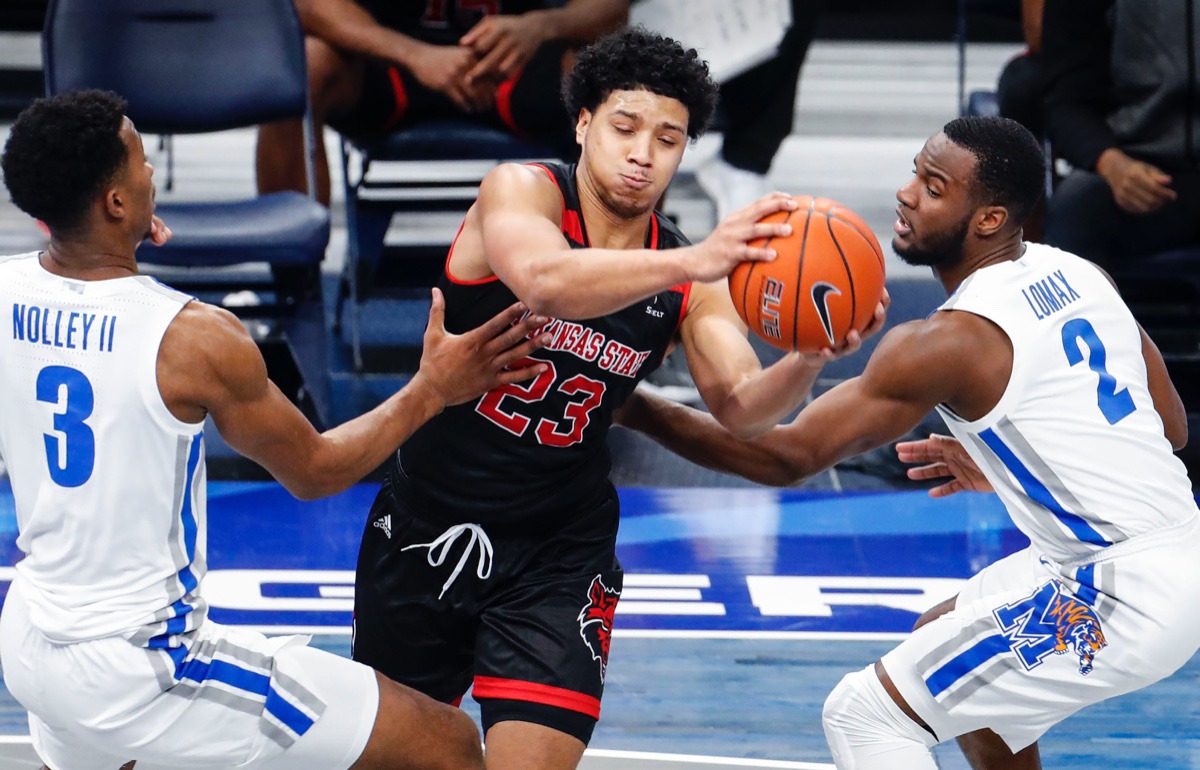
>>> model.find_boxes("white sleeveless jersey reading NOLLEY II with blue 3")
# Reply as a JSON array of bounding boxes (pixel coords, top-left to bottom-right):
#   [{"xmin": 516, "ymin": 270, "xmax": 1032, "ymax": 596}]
[{"xmin": 0, "ymin": 254, "xmax": 206, "ymax": 646}]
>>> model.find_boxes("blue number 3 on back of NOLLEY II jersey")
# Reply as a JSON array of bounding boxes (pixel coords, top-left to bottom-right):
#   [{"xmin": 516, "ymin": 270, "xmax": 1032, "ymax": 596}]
[{"xmin": 37, "ymin": 366, "xmax": 96, "ymax": 487}]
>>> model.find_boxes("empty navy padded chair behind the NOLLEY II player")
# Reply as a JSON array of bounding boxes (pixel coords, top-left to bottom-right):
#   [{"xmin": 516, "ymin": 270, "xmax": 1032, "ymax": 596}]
[{"xmin": 42, "ymin": 0, "xmax": 330, "ymax": 421}]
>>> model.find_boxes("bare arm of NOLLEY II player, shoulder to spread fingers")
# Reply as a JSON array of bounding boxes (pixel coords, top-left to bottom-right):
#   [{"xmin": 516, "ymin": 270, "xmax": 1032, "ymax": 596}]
[{"xmin": 158, "ymin": 289, "xmax": 545, "ymax": 499}]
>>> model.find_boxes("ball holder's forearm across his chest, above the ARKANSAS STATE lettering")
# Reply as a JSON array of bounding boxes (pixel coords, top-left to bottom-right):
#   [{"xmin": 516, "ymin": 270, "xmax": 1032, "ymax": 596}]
[{"xmin": 518, "ymin": 248, "xmax": 689, "ymax": 320}]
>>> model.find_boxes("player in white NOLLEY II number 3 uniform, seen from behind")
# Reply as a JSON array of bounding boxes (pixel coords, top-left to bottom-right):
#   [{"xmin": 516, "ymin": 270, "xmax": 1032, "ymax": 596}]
[{"xmin": 0, "ymin": 91, "xmax": 552, "ymax": 770}]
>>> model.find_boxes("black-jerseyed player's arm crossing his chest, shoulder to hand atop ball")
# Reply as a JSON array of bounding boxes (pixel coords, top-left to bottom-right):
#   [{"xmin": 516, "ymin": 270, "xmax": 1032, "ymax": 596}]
[{"xmin": 475, "ymin": 163, "xmax": 796, "ymax": 320}]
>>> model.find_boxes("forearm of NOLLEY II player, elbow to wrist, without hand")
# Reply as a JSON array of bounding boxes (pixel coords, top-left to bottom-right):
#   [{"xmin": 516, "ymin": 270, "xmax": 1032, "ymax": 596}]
[{"xmin": 298, "ymin": 373, "xmax": 445, "ymax": 500}]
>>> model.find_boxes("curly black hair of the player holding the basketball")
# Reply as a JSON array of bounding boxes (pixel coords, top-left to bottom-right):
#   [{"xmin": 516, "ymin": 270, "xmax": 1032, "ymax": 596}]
[{"xmin": 563, "ymin": 26, "xmax": 716, "ymax": 139}]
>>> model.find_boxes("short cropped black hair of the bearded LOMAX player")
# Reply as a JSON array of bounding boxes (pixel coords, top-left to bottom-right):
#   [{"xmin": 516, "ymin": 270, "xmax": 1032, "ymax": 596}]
[{"xmin": 942, "ymin": 115, "xmax": 1046, "ymax": 225}]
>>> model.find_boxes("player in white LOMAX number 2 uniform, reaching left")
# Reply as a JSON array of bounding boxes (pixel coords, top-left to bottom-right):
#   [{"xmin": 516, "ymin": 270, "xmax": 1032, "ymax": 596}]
[{"xmin": 623, "ymin": 118, "xmax": 1200, "ymax": 770}]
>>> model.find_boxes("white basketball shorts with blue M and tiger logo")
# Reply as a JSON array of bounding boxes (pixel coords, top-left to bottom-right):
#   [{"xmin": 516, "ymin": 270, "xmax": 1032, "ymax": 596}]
[{"xmin": 883, "ymin": 519, "xmax": 1200, "ymax": 752}]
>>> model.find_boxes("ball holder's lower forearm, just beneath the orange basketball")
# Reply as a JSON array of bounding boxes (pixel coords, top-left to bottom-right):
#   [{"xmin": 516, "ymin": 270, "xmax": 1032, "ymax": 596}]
[{"xmin": 713, "ymin": 354, "xmax": 823, "ymax": 441}]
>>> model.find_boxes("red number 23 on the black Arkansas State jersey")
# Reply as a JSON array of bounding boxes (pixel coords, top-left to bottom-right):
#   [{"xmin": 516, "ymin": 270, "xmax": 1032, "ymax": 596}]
[{"xmin": 475, "ymin": 359, "xmax": 606, "ymax": 447}]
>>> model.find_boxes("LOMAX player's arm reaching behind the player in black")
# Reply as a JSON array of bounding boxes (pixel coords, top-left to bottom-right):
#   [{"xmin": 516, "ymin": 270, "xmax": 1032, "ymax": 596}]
[{"xmin": 617, "ymin": 321, "xmax": 964, "ymax": 486}]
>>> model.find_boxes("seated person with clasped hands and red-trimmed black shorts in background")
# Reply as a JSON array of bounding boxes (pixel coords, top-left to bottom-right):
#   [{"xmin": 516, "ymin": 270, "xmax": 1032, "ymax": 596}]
[{"xmin": 256, "ymin": 0, "xmax": 629, "ymax": 205}]
